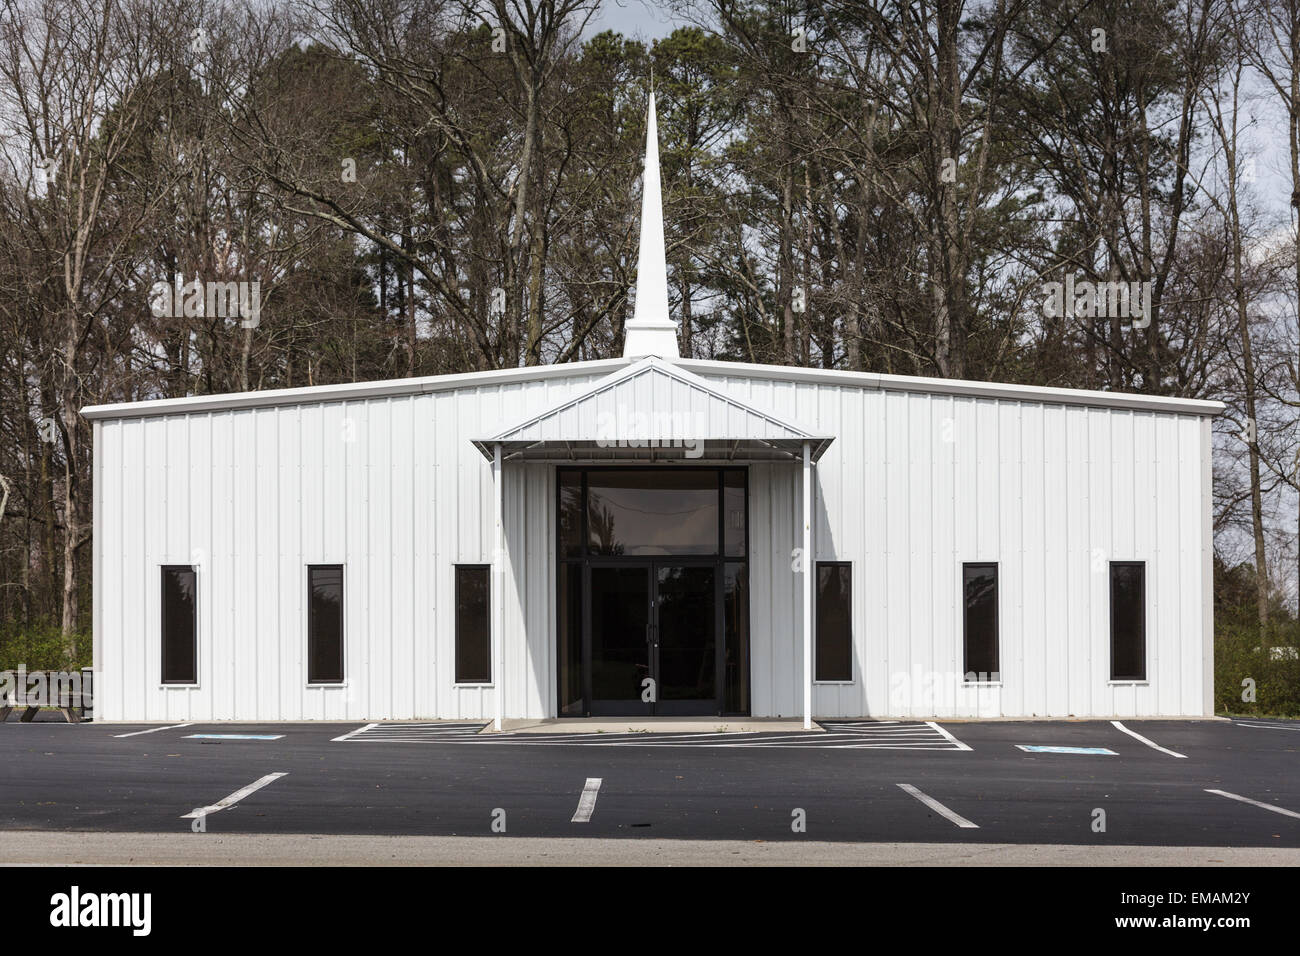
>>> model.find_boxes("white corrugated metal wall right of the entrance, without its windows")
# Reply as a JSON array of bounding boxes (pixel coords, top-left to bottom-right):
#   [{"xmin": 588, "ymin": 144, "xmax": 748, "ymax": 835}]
[{"xmin": 705, "ymin": 375, "xmax": 1213, "ymax": 717}]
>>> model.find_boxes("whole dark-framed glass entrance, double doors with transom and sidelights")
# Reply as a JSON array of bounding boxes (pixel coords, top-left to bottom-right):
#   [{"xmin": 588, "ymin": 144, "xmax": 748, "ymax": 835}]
[{"xmin": 556, "ymin": 467, "xmax": 750, "ymax": 715}]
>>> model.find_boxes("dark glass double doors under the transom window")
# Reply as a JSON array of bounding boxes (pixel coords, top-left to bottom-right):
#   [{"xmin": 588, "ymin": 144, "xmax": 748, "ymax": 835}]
[{"xmin": 585, "ymin": 559, "xmax": 722, "ymax": 717}]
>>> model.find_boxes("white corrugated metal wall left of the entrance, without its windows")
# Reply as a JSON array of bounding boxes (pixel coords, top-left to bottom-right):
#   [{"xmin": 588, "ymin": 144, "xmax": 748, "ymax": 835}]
[{"xmin": 94, "ymin": 376, "xmax": 605, "ymax": 721}]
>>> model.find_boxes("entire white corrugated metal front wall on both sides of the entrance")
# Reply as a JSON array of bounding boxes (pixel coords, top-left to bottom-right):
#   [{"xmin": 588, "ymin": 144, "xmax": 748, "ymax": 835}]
[{"xmin": 94, "ymin": 373, "xmax": 1210, "ymax": 721}]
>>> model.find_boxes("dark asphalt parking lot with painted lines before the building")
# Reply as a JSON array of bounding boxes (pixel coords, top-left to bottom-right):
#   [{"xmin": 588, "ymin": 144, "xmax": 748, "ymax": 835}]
[{"xmin": 0, "ymin": 721, "xmax": 1300, "ymax": 848}]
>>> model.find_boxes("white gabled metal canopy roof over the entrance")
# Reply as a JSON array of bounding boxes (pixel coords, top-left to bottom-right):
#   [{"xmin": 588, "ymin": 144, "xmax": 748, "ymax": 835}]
[{"xmin": 475, "ymin": 356, "xmax": 833, "ymax": 462}]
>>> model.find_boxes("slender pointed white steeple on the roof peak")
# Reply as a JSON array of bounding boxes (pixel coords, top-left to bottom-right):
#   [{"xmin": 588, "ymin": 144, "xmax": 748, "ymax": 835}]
[{"xmin": 623, "ymin": 90, "xmax": 679, "ymax": 359}]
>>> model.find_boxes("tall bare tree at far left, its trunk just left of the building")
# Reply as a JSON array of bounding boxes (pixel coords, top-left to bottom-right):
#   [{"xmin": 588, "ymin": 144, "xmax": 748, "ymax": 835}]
[{"xmin": 0, "ymin": 0, "xmax": 175, "ymax": 656}]
